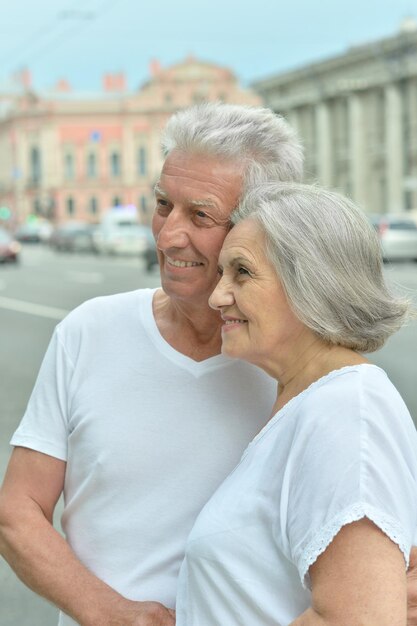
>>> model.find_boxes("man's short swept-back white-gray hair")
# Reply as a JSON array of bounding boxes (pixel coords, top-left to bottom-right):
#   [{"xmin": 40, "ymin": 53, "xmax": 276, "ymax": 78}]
[{"xmin": 162, "ymin": 102, "xmax": 303, "ymax": 190}]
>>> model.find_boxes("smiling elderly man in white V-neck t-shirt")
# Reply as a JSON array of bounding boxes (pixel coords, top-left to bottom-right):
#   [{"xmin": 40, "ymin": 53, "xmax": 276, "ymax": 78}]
[{"xmin": 0, "ymin": 105, "xmax": 414, "ymax": 626}]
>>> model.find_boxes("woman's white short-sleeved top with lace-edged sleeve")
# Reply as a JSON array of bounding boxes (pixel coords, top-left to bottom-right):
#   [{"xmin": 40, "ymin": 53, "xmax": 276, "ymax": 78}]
[{"xmin": 176, "ymin": 364, "xmax": 417, "ymax": 626}]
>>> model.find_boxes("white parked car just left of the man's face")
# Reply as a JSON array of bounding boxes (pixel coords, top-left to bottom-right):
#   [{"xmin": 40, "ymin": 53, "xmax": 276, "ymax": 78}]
[{"xmin": 94, "ymin": 222, "xmax": 152, "ymax": 256}]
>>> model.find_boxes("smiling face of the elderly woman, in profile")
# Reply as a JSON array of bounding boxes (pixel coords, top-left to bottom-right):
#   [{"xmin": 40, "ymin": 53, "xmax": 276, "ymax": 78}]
[{"xmin": 209, "ymin": 219, "xmax": 306, "ymax": 370}]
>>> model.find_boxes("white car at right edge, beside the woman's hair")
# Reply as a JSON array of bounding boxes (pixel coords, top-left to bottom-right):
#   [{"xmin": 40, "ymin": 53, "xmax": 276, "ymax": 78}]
[{"xmin": 370, "ymin": 214, "xmax": 417, "ymax": 261}]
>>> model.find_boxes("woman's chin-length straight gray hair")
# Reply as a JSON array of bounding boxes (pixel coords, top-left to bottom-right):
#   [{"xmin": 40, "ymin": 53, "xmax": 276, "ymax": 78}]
[{"xmin": 232, "ymin": 183, "xmax": 410, "ymax": 352}]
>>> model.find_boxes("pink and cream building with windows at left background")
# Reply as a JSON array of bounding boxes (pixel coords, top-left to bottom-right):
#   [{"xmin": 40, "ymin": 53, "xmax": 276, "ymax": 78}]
[{"xmin": 0, "ymin": 57, "xmax": 261, "ymax": 227}]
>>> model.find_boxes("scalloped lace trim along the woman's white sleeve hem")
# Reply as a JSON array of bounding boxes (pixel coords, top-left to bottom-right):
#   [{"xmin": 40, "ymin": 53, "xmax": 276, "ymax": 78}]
[{"xmin": 298, "ymin": 503, "xmax": 410, "ymax": 590}]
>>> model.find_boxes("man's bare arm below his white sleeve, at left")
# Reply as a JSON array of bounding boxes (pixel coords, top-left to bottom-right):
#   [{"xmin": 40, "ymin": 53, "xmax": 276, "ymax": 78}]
[{"xmin": 0, "ymin": 448, "xmax": 175, "ymax": 626}]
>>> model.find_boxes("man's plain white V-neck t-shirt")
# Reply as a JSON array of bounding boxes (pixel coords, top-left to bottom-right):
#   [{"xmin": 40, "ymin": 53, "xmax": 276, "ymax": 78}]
[{"xmin": 11, "ymin": 289, "xmax": 276, "ymax": 626}]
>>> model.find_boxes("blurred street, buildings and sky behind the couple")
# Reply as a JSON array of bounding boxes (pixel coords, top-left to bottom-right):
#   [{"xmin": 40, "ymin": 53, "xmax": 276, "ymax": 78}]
[{"xmin": 0, "ymin": 0, "xmax": 417, "ymax": 626}]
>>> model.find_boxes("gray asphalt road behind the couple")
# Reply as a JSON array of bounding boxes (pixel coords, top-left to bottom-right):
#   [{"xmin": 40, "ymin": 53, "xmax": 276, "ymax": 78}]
[{"xmin": 0, "ymin": 246, "xmax": 417, "ymax": 626}]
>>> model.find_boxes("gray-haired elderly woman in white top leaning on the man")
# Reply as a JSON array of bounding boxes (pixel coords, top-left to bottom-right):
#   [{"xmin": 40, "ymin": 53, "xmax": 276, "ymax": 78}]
[{"xmin": 173, "ymin": 184, "xmax": 417, "ymax": 626}]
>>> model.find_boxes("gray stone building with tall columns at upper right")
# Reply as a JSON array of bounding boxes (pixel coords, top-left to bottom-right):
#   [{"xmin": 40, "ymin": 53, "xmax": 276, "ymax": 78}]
[{"xmin": 253, "ymin": 19, "xmax": 417, "ymax": 213}]
